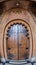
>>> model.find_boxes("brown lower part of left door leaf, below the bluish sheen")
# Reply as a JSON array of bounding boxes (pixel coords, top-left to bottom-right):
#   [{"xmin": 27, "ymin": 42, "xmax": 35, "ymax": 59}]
[{"xmin": 7, "ymin": 34, "xmax": 18, "ymax": 60}]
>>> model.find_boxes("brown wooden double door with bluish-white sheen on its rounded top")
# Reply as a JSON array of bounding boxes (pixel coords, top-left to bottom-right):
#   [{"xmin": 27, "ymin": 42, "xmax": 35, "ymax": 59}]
[{"xmin": 7, "ymin": 24, "xmax": 29, "ymax": 60}]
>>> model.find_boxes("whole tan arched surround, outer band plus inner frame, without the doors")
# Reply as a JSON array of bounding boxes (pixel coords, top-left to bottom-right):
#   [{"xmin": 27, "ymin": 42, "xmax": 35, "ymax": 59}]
[{"xmin": 0, "ymin": 8, "xmax": 36, "ymax": 58}]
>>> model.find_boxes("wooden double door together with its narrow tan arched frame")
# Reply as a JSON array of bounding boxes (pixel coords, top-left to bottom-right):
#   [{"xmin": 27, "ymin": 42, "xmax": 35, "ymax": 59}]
[{"xmin": 4, "ymin": 19, "xmax": 31, "ymax": 60}]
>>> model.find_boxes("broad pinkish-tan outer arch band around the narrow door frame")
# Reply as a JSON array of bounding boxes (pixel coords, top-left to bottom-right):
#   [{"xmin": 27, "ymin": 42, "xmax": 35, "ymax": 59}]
[{"xmin": 1, "ymin": 8, "xmax": 35, "ymax": 58}]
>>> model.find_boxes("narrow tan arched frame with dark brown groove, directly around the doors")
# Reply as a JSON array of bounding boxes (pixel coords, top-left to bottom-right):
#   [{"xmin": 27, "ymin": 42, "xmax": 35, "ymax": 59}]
[{"xmin": 3, "ymin": 19, "xmax": 33, "ymax": 58}]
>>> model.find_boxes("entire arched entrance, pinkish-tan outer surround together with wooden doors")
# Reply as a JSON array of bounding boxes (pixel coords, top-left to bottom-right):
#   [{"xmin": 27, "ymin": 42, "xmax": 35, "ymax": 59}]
[{"xmin": 0, "ymin": 8, "xmax": 35, "ymax": 60}]
